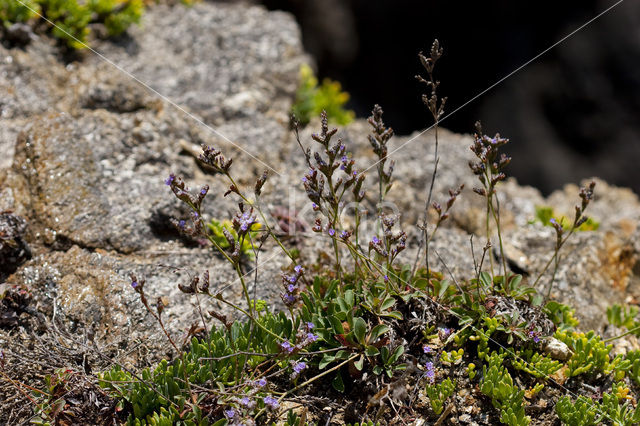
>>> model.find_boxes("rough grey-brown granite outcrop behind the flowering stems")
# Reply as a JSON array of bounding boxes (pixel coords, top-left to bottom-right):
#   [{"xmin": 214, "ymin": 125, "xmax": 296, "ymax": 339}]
[{"xmin": 0, "ymin": 3, "xmax": 640, "ymax": 402}]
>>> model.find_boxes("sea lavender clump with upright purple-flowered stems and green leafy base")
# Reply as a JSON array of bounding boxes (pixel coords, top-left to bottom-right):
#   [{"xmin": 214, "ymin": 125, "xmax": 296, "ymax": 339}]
[{"xmin": 96, "ymin": 41, "xmax": 616, "ymax": 426}]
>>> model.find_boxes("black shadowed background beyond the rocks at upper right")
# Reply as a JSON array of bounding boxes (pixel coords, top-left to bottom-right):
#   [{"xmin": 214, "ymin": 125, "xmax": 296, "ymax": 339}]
[{"xmin": 261, "ymin": 0, "xmax": 640, "ymax": 193}]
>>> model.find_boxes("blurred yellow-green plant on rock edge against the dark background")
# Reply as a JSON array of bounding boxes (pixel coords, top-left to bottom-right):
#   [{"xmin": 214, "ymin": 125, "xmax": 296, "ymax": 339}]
[{"xmin": 291, "ymin": 64, "xmax": 355, "ymax": 126}]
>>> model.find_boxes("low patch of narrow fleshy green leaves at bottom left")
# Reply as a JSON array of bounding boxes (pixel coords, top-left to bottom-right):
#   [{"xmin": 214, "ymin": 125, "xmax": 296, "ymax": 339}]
[{"xmin": 99, "ymin": 312, "xmax": 299, "ymax": 425}]
